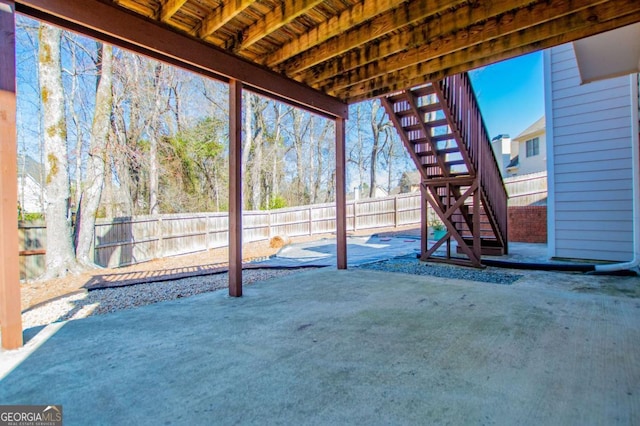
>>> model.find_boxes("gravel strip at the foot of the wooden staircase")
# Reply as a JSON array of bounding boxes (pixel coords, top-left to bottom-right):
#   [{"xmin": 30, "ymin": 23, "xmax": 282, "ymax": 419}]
[{"xmin": 360, "ymin": 256, "xmax": 522, "ymax": 285}]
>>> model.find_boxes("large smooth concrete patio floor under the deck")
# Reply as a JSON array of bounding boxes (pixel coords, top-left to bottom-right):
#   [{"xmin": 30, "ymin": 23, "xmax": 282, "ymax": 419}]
[{"xmin": 0, "ymin": 269, "xmax": 640, "ymax": 425}]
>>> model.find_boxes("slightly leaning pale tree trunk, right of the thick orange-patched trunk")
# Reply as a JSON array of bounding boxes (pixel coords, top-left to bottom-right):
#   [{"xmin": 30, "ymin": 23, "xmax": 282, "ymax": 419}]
[{"xmin": 76, "ymin": 44, "xmax": 112, "ymax": 266}]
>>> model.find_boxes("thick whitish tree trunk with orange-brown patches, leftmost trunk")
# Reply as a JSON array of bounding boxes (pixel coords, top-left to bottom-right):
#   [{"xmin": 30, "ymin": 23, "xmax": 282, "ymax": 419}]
[{"xmin": 38, "ymin": 25, "xmax": 78, "ymax": 278}]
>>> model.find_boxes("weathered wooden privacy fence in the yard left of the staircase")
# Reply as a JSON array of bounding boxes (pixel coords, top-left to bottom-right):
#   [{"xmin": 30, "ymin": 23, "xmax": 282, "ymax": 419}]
[{"xmin": 19, "ymin": 193, "xmax": 420, "ymax": 279}]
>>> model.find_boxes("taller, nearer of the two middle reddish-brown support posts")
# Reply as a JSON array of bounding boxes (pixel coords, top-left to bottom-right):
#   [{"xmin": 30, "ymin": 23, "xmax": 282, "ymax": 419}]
[{"xmin": 229, "ymin": 80, "xmax": 242, "ymax": 297}]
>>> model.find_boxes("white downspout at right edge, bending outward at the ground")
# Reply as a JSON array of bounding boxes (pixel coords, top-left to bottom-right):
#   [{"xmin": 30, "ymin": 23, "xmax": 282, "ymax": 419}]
[{"xmin": 596, "ymin": 74, "xmax": 640, "ymax": 273}]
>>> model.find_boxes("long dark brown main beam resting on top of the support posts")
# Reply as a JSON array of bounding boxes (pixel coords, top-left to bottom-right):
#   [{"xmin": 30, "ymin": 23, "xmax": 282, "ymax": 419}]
[{"xmin": 16, "ymin": 0, "xmax": 348, "ymax": 118}]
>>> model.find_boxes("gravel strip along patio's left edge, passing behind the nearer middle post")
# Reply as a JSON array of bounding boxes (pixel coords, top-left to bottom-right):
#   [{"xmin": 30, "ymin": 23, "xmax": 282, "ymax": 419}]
[{"xmin": 22, "ymin": 269, "xmax": 300, "ymax": 329}]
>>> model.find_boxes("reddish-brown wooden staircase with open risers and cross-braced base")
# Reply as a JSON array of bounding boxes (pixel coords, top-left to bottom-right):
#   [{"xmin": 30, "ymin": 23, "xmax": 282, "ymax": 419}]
[{"xmin": 381, "ymin": 73, "xmax": 508, "ymax": 267}]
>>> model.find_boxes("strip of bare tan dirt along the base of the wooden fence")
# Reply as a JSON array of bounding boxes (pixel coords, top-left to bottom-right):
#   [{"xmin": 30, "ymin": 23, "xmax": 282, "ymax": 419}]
[{"xmin": 21, "ymin": 226, "xmax": 420, "ymax": 311}]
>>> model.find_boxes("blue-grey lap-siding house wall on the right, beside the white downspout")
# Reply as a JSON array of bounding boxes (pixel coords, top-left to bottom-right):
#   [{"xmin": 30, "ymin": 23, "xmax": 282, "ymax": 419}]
[{"xmin": 544, "ymin": 44, "xmax": 637, "ymax": 261}]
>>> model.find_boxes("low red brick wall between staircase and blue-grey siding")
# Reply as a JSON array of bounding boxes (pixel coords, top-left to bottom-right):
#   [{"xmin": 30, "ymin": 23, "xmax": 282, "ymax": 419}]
[{"xmin": 508, "ymin": 206, "xmax": 547, "ymax": 243}]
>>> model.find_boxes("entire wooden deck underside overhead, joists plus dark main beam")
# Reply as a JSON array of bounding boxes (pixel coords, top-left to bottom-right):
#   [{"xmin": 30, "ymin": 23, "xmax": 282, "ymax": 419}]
[{"xmin": 11, "ymin": 0, "xmax": 640, "ymax": 104}]
